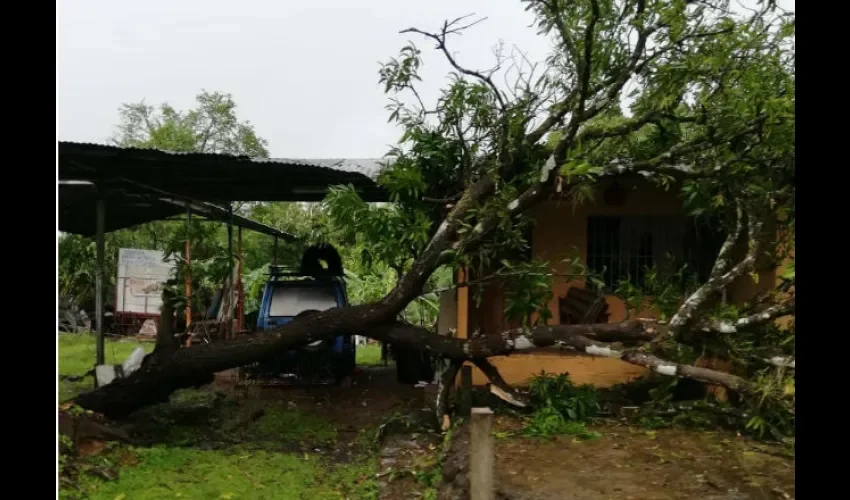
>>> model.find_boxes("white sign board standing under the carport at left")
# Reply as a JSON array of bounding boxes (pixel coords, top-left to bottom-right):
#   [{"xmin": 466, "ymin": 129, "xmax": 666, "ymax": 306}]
[{"xmin": 115, "ymin": 248, "xmax": 174, "ymax": 314}]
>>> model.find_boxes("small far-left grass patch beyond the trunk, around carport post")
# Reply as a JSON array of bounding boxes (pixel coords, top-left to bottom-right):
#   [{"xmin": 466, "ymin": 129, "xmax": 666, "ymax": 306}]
[{"xmin": 57, "ymin": 333, "xmax": 153, "ymax": 401}]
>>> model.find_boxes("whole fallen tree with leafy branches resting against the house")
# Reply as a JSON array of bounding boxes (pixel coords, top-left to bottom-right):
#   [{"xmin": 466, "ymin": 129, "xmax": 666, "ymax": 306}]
[{"xmin": 69, "ymin": 0, "xmax": 794, "ymax": 426}]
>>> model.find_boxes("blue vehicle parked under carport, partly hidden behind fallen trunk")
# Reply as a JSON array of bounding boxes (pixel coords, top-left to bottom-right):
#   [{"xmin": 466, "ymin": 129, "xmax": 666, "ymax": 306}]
[{"xmin": 247, "ymin": 266, "xmax": 356, "ymax": 383}]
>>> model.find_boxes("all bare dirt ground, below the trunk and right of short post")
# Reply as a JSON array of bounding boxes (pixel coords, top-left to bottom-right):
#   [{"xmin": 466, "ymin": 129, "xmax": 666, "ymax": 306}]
[{"xmin": 69, "ymin": 367, "xmax": 795, "ymax": 500}]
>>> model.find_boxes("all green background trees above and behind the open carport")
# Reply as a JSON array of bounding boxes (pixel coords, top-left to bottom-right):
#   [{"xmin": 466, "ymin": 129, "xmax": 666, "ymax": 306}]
[{"xmin": 58, "ymin": 91, "xmax": 448, "ymax": 326}]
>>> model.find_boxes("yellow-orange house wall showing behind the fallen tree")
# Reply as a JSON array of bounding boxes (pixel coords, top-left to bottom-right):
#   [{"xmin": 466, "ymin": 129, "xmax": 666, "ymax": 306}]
[{"xmin": 469, "ymin": 179, "xmax": 775, "ymax": 387}]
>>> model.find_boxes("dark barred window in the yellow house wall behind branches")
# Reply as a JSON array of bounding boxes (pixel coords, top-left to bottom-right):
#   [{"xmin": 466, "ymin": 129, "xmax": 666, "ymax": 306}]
[{"xmin": 587, "ymin": 216, "xmax": 723, "ymax": 292}]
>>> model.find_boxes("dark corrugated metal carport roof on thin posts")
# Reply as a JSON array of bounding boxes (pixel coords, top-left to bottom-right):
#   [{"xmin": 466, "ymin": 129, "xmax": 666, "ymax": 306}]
[{"xmin": 58, "ymin": 142, "xmax": 387, "ymax": 235}]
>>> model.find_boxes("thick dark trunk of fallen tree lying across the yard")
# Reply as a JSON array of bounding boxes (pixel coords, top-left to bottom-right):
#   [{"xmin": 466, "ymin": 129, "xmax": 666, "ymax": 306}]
[{"xmin": 74, "ymin": 303, "xmax": 750, "ymax": 417}]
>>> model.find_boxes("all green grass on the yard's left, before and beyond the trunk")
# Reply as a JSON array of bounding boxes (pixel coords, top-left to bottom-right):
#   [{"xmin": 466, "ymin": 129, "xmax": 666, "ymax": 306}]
[{"xmin": 58, "ymin": 335, "xmax": 380, "ymax": 500}]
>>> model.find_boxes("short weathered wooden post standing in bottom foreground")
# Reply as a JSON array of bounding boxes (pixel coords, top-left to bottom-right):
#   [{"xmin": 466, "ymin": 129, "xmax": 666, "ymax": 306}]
[{"xmin": 469, "ymin": 408, "xmax": 495, "ymax": 500}]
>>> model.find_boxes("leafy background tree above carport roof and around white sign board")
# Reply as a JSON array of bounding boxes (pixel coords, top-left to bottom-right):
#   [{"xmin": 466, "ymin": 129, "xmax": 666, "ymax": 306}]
[{"xmin": 58, "ymin": 91, "xmax": 268, "ymax": 316}]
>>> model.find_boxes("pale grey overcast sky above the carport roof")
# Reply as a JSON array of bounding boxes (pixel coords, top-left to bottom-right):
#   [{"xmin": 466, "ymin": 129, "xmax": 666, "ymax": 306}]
[{"xmin": 56, "ymin": 0, "xmax": 549, "ymax": 158}]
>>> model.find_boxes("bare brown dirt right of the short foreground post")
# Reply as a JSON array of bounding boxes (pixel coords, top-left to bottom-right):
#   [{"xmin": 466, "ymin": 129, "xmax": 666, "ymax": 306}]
[{"xmin": 496, "ymin": 418, "xmax": 794, "ymax": 500}]
